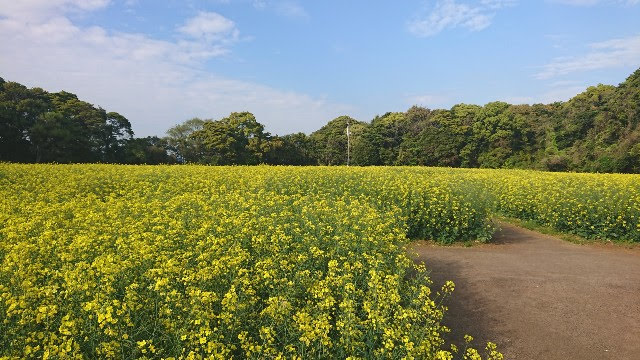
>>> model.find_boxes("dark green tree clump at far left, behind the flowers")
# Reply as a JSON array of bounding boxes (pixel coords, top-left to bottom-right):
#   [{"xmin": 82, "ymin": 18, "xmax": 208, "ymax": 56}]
[{"xmin": 0, "ymin": 80, "xmax": 133, "ymax": 163}]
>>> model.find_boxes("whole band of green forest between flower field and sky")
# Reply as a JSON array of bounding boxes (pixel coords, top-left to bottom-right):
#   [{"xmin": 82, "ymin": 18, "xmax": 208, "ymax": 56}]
[{"xmin": 0, "ymin": 69, "xmax": 640, "ymax": 173}]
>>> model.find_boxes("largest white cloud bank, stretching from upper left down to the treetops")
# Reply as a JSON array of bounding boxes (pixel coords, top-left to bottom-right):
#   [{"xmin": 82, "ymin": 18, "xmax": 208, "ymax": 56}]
[{"xmin": 0, "ymin": 0, "xmax": 354, "ymax": 136}]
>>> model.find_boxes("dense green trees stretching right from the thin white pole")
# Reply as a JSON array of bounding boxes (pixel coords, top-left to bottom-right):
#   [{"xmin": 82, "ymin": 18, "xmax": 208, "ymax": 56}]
[{"xmin": 344, "ymin": 70, "xmax": 640, "ymax": 172}]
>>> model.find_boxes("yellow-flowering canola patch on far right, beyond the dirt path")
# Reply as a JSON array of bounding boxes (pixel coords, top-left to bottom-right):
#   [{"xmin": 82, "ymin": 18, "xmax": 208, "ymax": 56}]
[{"xmin": 479, "ymin": 170, "xmax": 640, "ymax": 243}]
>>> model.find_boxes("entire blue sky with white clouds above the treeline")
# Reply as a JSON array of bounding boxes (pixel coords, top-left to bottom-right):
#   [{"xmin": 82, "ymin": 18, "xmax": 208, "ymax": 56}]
[{"xmin": 0, "ymin": 0, "xmax": 640, "ymax": 136}]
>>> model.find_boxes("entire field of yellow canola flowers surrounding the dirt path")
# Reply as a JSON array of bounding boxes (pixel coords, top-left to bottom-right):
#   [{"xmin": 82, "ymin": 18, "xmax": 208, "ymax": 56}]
[{"xmin": 0, "ymin": 164, "xmax": 640, "ymax": 359}]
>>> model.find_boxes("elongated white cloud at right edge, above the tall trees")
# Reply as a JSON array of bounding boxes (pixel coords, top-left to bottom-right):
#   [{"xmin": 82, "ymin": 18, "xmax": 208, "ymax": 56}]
[{"xmin": 535, "ymin": 35, "xmax": 640, "ymax": 79}]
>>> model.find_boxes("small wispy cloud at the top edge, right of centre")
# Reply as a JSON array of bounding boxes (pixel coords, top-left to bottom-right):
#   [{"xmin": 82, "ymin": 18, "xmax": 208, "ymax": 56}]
[{"xmin": 407, "ymin": 0, "xmax": 517, "ymax": 37}]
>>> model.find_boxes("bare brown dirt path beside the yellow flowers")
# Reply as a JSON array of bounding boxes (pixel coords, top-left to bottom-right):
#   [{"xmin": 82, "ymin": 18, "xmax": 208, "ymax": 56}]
[{"xmin": 412, "ymin": 224, "xmax": 640, "ymax": 360}]
